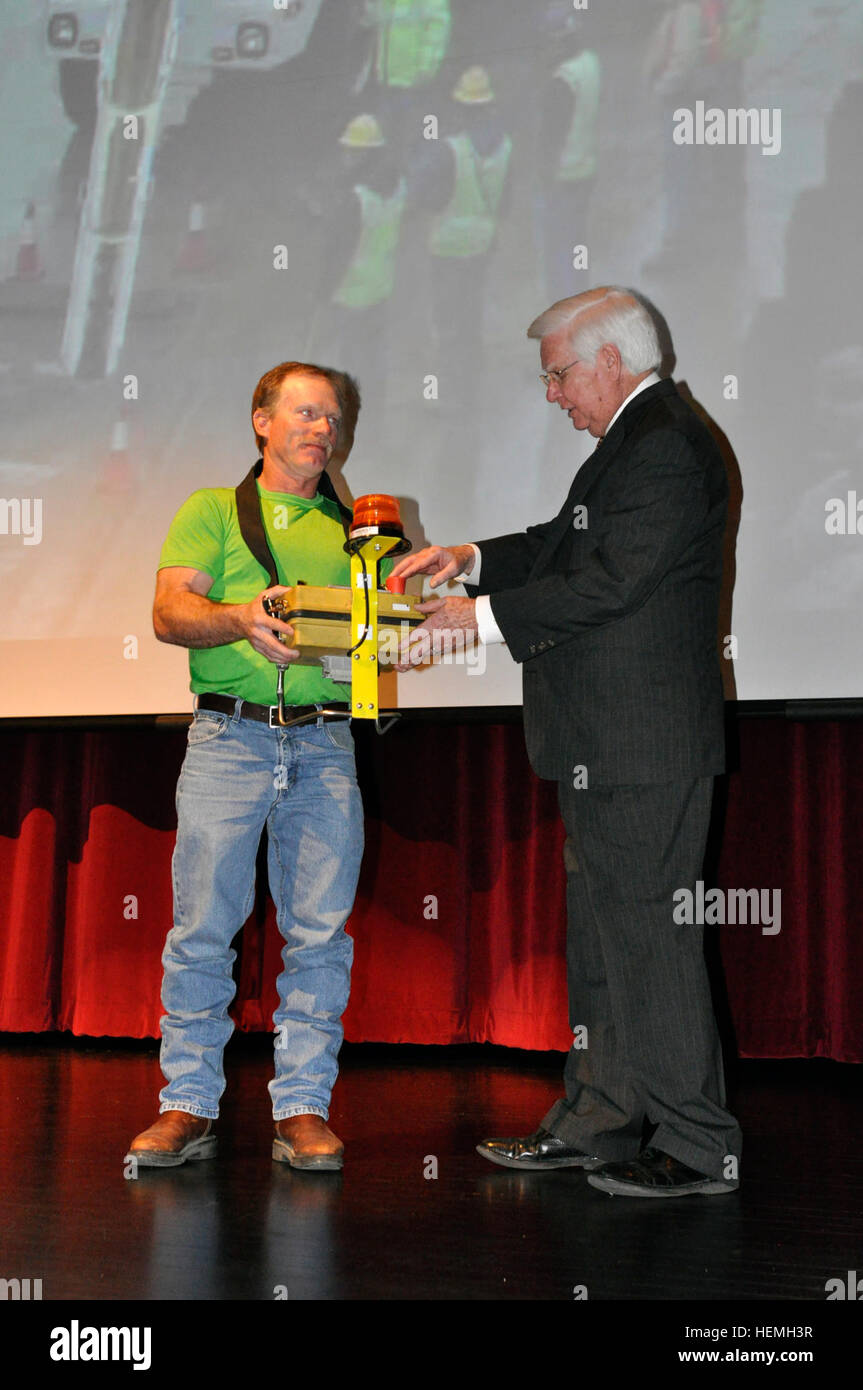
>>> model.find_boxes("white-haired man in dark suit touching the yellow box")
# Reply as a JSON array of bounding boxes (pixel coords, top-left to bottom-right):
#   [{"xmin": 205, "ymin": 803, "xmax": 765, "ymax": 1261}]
[{"xmin": 395, "ymin": 288, "xmax": 741, "ymax": 1197}]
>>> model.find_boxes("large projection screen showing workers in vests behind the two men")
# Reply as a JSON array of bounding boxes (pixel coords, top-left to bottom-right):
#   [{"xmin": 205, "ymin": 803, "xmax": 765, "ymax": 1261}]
[{"xmin": 0, "ymin": 0, "xmax": 863, "ymax": 717}]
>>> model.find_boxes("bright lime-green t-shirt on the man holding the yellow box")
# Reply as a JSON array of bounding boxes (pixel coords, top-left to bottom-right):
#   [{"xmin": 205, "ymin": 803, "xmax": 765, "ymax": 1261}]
[{"xmin": 158, "ymin": 484, "xmax": 350, "ymax": 705}]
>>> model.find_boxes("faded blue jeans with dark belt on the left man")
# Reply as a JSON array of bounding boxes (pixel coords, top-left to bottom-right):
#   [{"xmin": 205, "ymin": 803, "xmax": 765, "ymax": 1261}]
[{"xmin": 158, "ymin": 702, "xmax": 363, "ymax": 1120}]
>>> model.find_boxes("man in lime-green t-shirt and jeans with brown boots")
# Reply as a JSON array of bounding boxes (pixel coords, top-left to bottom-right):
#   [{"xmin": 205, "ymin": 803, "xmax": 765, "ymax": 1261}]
[{"xmin": 126, "ymin": 361, "xmax": 363, "ymax": 1169}]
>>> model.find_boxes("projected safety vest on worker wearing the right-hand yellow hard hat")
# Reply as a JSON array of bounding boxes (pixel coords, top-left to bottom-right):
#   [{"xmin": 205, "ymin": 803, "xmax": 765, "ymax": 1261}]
[{"xmin": 428, "ymin": 135, "xmax": 513, "ymax": 256}]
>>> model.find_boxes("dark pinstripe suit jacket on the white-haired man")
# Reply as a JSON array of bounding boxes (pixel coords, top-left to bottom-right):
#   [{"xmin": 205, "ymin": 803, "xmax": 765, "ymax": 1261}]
[{"xmin": 474, "ymin": 381, "xmax": 727, "ymax": 787}]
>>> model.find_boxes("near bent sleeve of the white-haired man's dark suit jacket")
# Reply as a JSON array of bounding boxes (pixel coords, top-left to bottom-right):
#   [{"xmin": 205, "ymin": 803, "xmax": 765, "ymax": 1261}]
[{"xmin": 481, "ymin": 430, "xmax": 712, "ymax": 662}]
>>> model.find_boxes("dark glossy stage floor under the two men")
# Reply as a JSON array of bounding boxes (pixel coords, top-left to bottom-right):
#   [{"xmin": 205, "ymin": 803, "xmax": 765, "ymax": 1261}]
[{"xmin": 0, "ymin": 1036, "xmax": 863, "ymax": 1323}]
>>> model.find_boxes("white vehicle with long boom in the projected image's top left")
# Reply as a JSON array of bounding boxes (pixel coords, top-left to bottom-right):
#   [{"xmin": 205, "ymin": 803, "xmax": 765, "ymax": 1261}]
[{"xmin": 44, "ymin": 0, "xmax": 321, "ymax": 377}]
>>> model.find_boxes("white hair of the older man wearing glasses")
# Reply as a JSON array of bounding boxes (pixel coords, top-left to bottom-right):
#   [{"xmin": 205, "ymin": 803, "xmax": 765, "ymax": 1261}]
[{"xmin": 528, "ymin": 285, "xmax": 661, "ymax": 377}]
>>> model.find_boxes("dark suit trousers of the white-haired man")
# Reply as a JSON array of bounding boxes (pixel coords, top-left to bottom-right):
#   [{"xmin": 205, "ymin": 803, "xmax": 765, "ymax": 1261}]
[{"xmin": 542, "ymin": 777, "xmax": 741, "ymax": 1177}]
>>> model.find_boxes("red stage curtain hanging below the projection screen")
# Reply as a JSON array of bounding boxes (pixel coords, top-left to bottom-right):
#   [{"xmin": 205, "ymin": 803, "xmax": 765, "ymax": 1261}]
[{"xmin": 0, "ymin": 719, "xmax": 863, "ymax": 1062}]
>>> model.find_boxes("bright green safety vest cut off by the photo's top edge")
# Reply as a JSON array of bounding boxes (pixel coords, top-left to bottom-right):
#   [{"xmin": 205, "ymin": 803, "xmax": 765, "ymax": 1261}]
[{"xmin": 365, "ymin": 0, "xmax": 452, "ymax": 88}]
